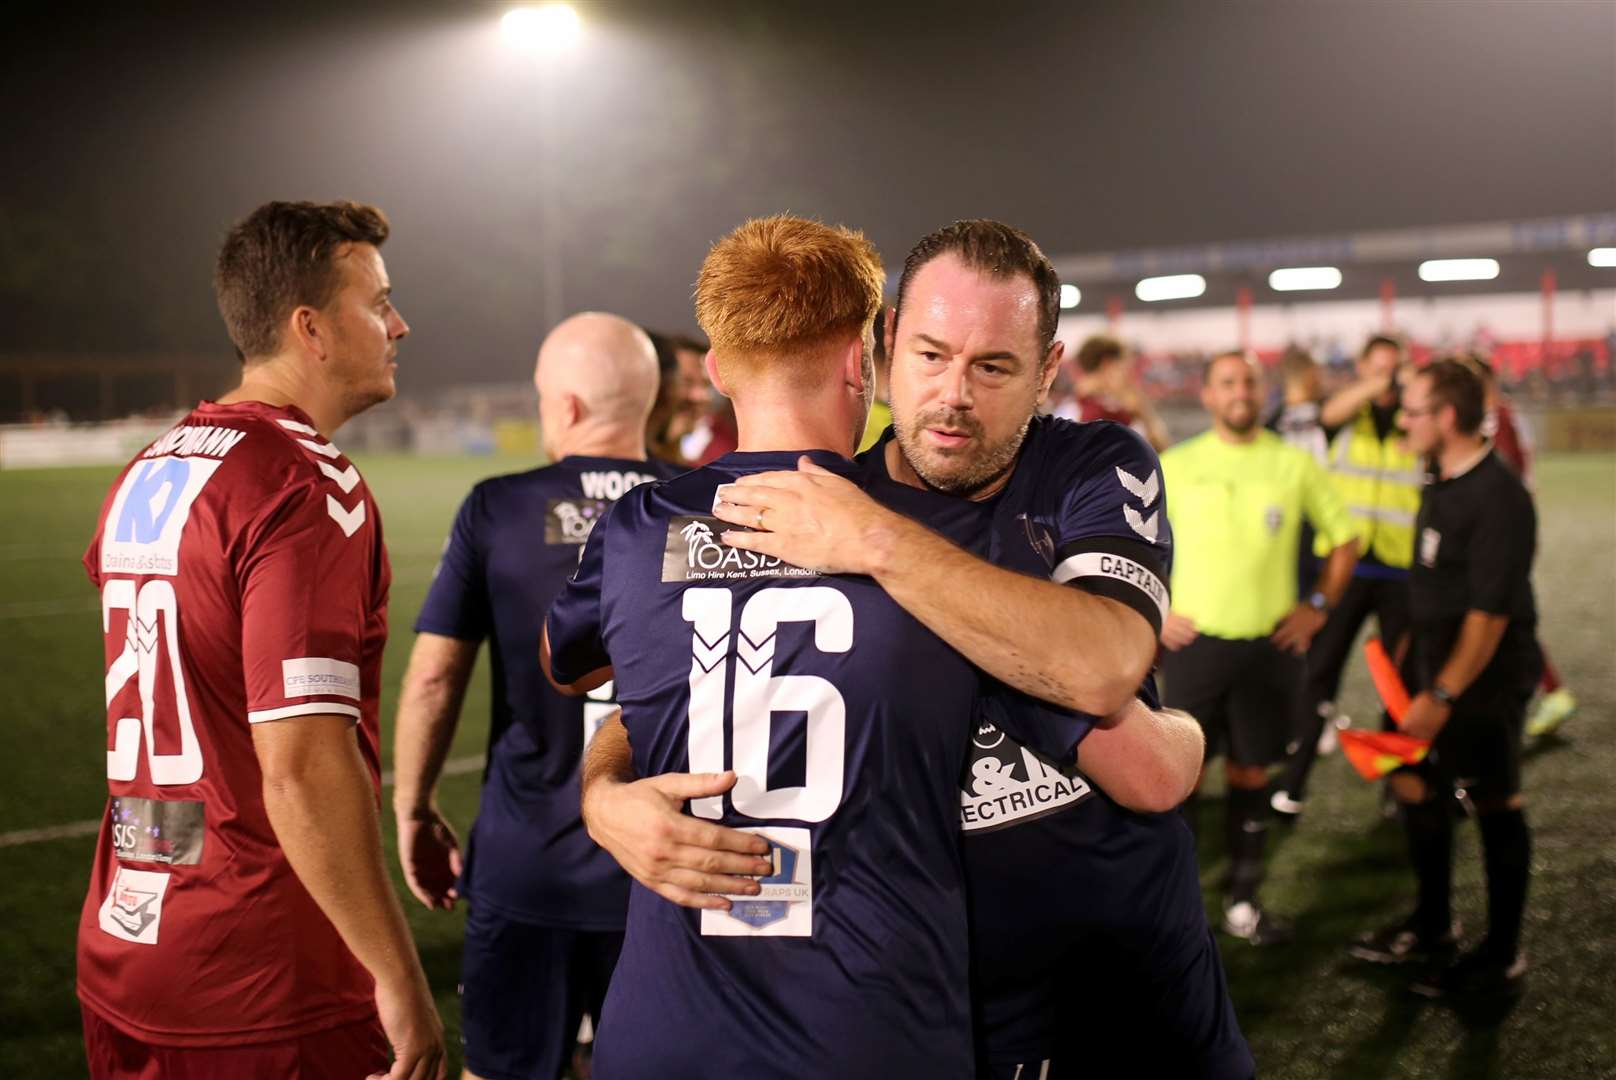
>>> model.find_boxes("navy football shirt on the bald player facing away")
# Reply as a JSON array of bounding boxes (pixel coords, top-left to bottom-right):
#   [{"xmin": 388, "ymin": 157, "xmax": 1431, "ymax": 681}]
[{"xmin": 415, "ymin": 456, "xmax": 677, "ymax": 931}]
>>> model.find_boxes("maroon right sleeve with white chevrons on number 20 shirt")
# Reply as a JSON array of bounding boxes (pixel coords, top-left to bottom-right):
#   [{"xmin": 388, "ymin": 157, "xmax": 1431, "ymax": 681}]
[{"xmin": 238, "ymin": 482, "xmax": 378, "ymax": 724}]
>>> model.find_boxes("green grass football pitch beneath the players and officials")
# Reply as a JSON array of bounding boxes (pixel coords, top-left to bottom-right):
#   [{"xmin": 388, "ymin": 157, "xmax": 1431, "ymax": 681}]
[{"xmin": 0, "ymin": 454, "xmax": 1616, "ymax": 1080}]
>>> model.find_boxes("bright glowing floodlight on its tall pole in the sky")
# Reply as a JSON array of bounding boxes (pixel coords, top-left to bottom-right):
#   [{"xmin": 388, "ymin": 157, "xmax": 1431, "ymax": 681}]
[{"xmin": 499, "ymin": 3, "xmax": 583, "ymax": 330}]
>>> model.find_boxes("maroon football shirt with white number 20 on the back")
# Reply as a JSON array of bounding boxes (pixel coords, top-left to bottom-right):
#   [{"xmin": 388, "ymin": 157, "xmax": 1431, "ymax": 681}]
[{"xmin": 78, "ymin": 403, "xmax": 391, "ymax": 1046}]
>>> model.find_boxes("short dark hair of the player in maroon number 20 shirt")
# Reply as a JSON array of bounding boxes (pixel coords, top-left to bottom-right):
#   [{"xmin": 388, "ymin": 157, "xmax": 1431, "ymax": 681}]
[{"xmin": 213, "ymin": 202, "xmax": 388, "ymax": 362}]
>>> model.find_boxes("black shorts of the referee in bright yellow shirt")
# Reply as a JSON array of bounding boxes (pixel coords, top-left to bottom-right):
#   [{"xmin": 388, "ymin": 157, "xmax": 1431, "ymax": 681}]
[{"xmin": 1162, "ymin": 634, "xmax": 1307, "ymax": 765}]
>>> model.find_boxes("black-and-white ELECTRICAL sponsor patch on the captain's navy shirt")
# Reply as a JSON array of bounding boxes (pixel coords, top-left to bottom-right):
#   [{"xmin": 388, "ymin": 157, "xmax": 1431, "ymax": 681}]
[{"xmin": 960, "ymin": 721, "xmax": 1094, "ymax": 833}]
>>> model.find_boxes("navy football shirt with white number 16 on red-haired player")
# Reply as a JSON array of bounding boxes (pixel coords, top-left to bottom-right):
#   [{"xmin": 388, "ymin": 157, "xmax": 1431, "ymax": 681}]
[{"xmin": 548, "ymin": 453, "xmax": 1088, "ymax": 1080}]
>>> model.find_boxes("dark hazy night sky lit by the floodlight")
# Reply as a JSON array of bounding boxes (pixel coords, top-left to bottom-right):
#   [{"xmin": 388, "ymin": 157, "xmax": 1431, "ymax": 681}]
[{"xmin": 0, "ymin": 0, "xmax": 1616, "ymax": 393}]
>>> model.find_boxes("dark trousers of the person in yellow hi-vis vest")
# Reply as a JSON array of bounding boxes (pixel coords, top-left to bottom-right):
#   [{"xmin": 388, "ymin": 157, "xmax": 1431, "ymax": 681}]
[{"xmin": 1277, "ymin": 577, "xmax": 1409, "ymax": 800}]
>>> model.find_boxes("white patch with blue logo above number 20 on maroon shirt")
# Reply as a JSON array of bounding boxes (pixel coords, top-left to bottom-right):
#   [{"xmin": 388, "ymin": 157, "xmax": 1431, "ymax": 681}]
[{"xmin": 100, "ymin": 452, "xmax": 221, "ymax": 576}]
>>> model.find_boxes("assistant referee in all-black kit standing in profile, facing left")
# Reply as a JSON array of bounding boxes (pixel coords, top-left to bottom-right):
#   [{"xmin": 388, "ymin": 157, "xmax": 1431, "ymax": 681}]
[{"xmin": 1353, "ymin": 361, "xmax": 1542, "ymax": 998}]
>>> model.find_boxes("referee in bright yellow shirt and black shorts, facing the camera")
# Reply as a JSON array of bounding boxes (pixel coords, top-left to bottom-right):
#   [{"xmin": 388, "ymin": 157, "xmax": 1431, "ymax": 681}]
[{"xmin": 1162, "ymin": 352, "xmax": 1357, "ymax": 944}]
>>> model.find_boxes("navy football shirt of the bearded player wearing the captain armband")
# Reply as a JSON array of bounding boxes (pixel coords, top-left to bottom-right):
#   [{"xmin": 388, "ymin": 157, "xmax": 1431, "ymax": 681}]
[{"xmin": 960, "ymin": 417, "xmax": 1251, "ymax": 1075}]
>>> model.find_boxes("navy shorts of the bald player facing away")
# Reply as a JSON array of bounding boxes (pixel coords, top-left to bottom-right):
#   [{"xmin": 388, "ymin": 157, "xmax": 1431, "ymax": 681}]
[{"xmin": 461, "ymin": 904, "xmax": 622, "ymax": 1080}]
